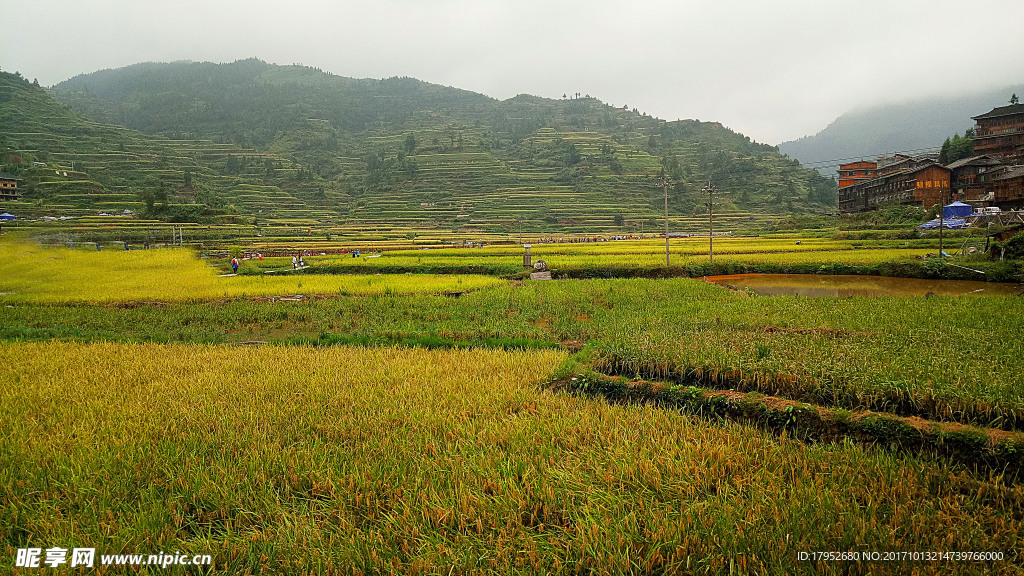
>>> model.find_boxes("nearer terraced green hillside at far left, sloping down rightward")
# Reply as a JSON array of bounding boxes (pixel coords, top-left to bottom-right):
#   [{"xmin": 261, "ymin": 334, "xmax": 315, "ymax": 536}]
[{"xmin": 0, "ymin": 73, "xmax": 327, "ymax": 226}]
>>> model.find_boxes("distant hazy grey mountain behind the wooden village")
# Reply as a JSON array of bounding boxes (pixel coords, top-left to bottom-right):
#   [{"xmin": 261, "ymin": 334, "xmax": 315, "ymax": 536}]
[{"xmin": 778, "ymin": 85, "xmax": 1024, "ymax": 175}]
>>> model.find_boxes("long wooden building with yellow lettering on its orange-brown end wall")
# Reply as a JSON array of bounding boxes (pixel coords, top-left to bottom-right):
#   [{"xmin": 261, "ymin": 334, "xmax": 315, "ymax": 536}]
[{"xmin": 839, "ymin": 162, "xmax": 952, "ymax": 212}]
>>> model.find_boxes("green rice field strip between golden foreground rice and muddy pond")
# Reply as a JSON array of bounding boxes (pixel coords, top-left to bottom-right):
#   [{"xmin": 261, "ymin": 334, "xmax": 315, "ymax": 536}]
[{"xmin": 8, "ymin": 277, "xmax": 1024, "ymax": 429}]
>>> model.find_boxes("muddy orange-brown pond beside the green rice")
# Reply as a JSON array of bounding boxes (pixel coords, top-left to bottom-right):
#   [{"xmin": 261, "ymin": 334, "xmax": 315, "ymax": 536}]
[{"xmin": 707, "ymin": 274, "xmax": 1024, "ymax": 297}]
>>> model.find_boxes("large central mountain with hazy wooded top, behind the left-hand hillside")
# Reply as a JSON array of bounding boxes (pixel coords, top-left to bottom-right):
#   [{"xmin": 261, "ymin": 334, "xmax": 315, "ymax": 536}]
[{"xmin": 6, "ymin": 59, "xmax": 835, "ymax": 230}]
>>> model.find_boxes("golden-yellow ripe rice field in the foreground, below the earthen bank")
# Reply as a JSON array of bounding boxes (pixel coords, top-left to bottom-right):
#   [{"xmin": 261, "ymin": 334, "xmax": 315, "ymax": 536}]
[{"xmin": 0, "ymin": 342, "xmax": 1024, "ymax": 575}]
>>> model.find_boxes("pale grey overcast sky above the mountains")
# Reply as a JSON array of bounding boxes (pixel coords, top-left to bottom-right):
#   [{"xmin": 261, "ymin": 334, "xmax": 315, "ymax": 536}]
[{"xmin": 0, "ymin": 0, "xmax": 1024, "ymax": 145}]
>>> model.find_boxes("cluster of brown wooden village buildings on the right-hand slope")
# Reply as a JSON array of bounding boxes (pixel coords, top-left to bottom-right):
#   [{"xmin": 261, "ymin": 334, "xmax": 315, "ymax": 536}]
[{"xmin": 839, "ymin": 94, "xmax": 1024, "ymax": 212}]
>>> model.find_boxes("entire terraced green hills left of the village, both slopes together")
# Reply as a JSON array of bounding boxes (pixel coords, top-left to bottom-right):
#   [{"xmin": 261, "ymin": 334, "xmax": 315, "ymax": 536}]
[{"xmin": 0, "ymin": 59, "xmax": 834, "ymax": 236}]
